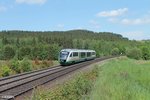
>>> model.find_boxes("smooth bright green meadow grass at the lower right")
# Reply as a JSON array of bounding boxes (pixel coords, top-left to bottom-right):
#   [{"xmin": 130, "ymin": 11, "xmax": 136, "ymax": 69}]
[{"xmin": 90, "ymin": 58, "xmax": 150, "ymax": 100}]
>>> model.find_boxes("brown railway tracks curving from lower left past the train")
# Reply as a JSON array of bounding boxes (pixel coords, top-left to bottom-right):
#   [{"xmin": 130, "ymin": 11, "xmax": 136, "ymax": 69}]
[{"xmin": 0, "ymin": 57, "xmax": 115, "ymax": 100}]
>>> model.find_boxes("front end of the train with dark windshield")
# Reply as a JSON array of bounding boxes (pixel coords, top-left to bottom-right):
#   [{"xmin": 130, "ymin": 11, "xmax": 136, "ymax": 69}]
[{"xmin": 59, "ymin": 50, "xmax": 69, "ymax": 65}]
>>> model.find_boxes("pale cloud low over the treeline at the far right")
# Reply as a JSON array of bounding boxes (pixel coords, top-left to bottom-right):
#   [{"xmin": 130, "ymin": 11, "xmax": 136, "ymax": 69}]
[{"xmin": 121, "ymin": 31, "xmax": 150, "ymax": 40}]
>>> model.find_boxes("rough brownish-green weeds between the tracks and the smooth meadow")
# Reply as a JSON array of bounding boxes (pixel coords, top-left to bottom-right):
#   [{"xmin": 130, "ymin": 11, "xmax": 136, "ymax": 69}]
[{"xmin": 30, "ymin": 67, "xmax": 98, "ymax": 100}]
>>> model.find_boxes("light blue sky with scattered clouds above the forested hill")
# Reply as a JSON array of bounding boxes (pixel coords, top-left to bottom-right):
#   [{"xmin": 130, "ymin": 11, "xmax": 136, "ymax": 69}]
[{"xmin": 0, "ymin": 0, "xmax": 150, "ymax": 40}]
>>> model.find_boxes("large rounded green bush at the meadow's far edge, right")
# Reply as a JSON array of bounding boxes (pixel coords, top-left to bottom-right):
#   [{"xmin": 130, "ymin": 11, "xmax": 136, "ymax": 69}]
[{"xmin": 126, "ymin": 48, "xmax": 142, "ymax": 60}]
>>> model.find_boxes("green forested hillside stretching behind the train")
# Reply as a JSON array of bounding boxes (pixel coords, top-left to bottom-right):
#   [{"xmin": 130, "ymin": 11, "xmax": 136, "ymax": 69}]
[{"xmin": 0, "ymin": 30, "xmax": 150, "ymax": 60}]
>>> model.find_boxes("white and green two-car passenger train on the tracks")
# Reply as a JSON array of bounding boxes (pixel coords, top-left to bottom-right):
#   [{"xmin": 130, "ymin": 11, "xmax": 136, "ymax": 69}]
[{"xmin": 58, "ymin": 49, "xmax": 96, "ymax": 65}]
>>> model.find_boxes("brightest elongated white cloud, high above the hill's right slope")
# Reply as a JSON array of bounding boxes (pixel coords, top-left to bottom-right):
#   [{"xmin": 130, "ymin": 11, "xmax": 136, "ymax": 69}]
[{"xmin": 97, "ymin": 8, "xmax": 128, "ymax": 17}]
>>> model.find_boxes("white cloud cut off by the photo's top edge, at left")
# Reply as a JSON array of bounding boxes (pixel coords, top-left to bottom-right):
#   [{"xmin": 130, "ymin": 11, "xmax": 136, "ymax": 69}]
[{"xmin": 16, "ymin": 0, "xmax": 47, "ymax": 4}]
